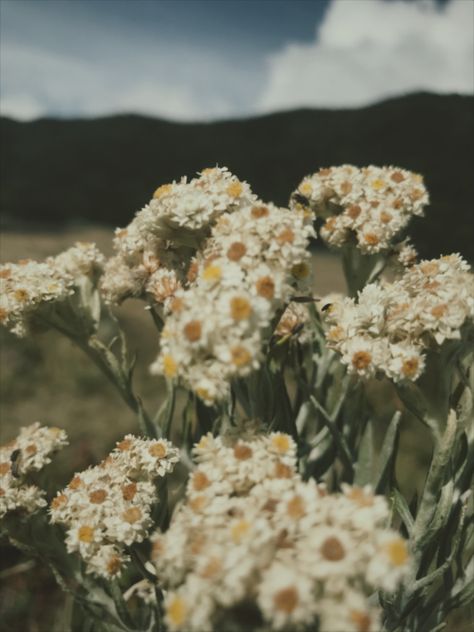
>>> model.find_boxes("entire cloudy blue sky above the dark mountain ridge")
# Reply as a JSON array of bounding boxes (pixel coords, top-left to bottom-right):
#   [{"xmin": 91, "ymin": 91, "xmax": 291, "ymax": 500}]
[{"xmin": 0, "ymin": 0, "xmax": 474, "ymax": 120}]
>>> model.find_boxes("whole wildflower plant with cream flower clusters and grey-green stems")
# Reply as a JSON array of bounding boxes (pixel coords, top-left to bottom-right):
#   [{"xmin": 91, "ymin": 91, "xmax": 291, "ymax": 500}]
[{"xmin": 0, "ymin": 165, "xmax": 474, "ymax": 632}]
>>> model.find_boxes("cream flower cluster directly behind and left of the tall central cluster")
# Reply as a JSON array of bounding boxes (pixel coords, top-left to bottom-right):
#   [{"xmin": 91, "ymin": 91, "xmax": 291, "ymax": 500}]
[{"xmin": 102, "ymin": 167, "xmax": 255, "ymax": 304}]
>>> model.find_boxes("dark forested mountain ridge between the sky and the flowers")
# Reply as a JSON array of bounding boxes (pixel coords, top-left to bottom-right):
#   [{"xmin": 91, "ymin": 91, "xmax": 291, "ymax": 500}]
[{"xmin": 0, "ymin": 93, "xmax": 474, "ymax": 260}]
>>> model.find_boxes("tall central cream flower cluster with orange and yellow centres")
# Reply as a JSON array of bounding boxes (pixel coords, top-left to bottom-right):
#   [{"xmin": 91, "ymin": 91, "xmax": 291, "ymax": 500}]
[{"xmin": 152, "ymin": 202, "xmax": 314, "ymax": 403}]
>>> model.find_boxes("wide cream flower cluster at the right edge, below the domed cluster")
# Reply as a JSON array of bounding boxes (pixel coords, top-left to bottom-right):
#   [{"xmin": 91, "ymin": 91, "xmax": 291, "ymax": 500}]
[{"xmin": 326, "ymin": 254, "xmax": 474, "ymax": 381}]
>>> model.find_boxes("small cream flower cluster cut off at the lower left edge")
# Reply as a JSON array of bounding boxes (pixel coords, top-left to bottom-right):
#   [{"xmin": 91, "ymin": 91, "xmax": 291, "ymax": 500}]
[{"xmin": 0, "ymin": 422, "xmax": 67, "ymax": 518}]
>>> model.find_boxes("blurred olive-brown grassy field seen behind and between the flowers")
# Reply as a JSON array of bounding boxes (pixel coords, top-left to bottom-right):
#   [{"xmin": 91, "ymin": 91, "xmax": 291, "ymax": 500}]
[{"xmin": 0, "ymin": 227, "xmax": 472, "ymax": 632}]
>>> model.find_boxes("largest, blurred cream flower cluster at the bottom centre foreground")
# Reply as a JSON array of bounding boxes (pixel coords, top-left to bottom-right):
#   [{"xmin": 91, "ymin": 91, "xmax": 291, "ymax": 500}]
[{"xmin": 152, "ymin": 432, "xmax": 410, "ymax": 632}]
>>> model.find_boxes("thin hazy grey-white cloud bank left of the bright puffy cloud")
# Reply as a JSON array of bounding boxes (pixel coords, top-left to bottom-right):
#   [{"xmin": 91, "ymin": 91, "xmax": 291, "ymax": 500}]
[{"xmin": 0, "ymin": 3, "xmax": 263, "ymax": 120}]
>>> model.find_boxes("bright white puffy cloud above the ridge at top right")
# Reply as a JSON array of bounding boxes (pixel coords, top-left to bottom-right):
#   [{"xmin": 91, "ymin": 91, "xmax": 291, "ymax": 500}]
[{"xmin": 257, "ymin": 0, "xmax": 474, "ymax": 111}]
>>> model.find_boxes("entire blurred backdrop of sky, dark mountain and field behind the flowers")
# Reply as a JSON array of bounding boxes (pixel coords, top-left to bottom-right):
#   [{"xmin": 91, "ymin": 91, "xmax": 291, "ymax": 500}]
[{"xmin": 0, "ymin": 0, "xmax": 474, "ymax": 632}]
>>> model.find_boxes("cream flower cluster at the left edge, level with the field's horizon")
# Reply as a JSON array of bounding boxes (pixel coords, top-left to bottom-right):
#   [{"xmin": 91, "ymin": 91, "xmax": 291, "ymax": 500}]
[{"xmin": 0, "ymin": 242, "xmax": 104, "ymax": 336}]
